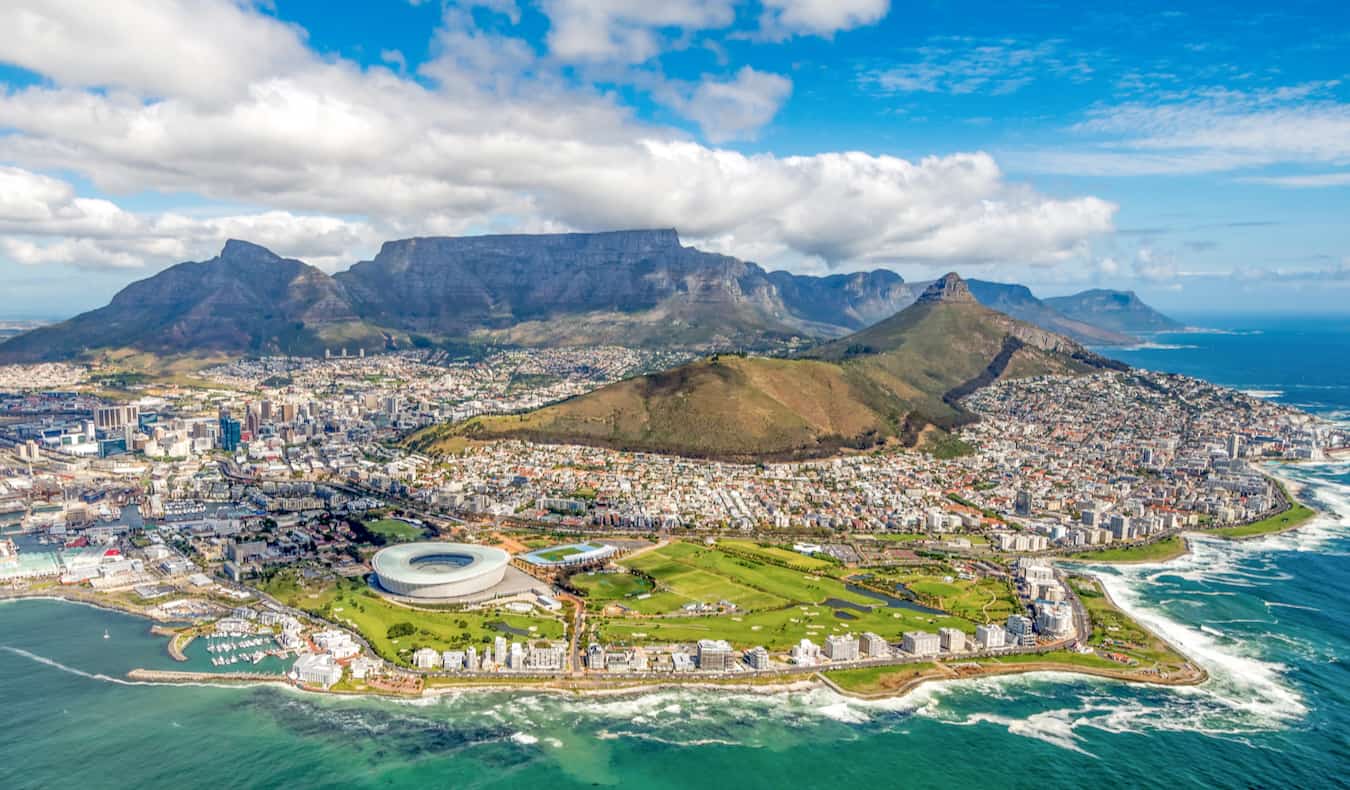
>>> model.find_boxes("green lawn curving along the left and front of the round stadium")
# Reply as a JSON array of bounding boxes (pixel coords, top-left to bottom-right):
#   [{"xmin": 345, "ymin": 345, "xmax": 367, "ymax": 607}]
[{"xmin": 263, "ymin": 573, "xmax": 563, "ymax": 666}]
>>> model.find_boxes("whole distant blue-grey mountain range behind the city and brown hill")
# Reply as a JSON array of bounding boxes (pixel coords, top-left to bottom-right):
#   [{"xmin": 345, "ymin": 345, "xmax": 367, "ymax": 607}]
[{"xmin": 0, "ymin": 230, "xmax": 1176, "ymax": 362}]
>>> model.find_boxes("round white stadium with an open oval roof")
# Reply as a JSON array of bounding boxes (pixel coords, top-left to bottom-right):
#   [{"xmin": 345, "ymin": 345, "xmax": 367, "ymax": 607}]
[{"xmin": 370, "ymin": 543, "xmax": 510, "ymax": 598}]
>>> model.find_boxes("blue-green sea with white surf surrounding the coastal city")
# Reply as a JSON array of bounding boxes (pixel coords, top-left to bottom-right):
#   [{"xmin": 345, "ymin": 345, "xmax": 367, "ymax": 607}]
[{"xmin": 0, "ymin": 316, "xmax": 1350, "ymax": 790}]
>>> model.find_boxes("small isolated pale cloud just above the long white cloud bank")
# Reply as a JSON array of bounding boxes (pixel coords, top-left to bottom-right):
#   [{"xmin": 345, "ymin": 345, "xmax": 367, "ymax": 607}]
[{"xmin": 671, "ymin": 66, "xmax": 792, "ymax": 143}]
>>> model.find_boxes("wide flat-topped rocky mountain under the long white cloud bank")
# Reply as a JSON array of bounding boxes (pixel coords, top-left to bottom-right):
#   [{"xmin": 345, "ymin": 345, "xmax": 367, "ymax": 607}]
[{"xmin": 336, "ymin": 230, "xmax": 913, "ymax": 348}]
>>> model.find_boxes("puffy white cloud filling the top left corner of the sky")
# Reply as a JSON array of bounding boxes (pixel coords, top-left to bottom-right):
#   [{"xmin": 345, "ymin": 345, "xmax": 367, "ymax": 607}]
[{"xmin": 0, "ymin": 0, "xmax": 312, "ymax": 100}]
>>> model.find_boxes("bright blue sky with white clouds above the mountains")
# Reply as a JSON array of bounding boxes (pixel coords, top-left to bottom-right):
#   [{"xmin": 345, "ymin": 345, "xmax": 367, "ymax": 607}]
[{"xmin": 0, "ymin": 0, "xmax": 1350, "ymax": 317}]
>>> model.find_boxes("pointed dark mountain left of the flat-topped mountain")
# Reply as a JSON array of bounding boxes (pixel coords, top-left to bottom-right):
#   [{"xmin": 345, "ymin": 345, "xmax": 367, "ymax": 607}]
[{"xmin": 0, "ymin": 240, "xmax": 385, "ymax": 362}]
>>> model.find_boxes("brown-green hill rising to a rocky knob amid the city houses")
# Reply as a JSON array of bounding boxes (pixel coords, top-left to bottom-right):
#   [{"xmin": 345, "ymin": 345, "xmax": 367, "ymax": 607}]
[{"xmin": 408, "ymin": 274, "xmax": 1122, "ymax": 460}]
